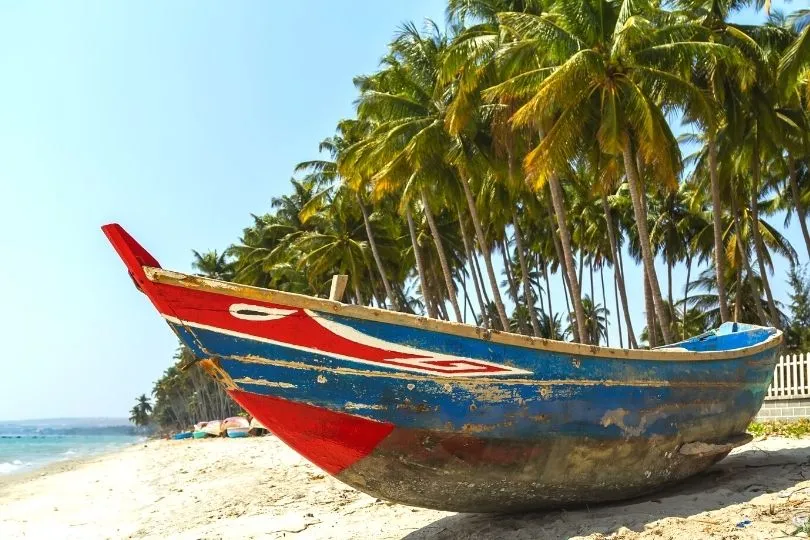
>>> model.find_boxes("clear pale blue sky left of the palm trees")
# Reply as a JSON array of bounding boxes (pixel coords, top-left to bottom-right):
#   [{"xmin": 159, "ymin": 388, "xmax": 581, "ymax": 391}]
[{"xmin": 0, "ymin": 0, "xmax": 801, "ymax": 419}]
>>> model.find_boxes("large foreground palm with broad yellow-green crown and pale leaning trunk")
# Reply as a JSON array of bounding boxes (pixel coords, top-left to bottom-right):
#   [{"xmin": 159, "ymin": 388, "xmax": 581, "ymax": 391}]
[{"xmin": 487, "ymin": 0, "xmax": 740, "ymax": 341}]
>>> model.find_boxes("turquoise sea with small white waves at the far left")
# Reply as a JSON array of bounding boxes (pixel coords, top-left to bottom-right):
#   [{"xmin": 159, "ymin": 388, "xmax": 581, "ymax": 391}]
[{"xmin": 0, "ymin": 418, "xmax": 145, "ymax": 476}]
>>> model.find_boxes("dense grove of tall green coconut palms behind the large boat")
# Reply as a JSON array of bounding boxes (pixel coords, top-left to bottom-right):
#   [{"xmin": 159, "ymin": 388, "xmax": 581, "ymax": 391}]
[{"xmin": 144, "ymin": 0, "xmax": 810, "ymax": 430}]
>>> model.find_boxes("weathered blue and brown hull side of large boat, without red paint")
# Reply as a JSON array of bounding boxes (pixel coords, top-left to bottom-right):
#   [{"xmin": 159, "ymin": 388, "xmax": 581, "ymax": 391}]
[{"xmin": 174, "ymin": 316, "xmax": 777, "ymax": 512}]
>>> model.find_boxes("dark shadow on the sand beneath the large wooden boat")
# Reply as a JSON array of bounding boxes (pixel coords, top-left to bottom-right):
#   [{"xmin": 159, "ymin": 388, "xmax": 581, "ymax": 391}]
[{"xmin": 405, "ymin": 442, "xmax": 810, "ymax": 540}]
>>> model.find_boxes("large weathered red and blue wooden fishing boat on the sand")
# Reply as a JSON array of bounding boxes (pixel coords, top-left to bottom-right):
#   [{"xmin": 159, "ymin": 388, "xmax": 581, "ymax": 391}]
[{"xmin": 103, "ymin": 225, "xmax": 782, "ymax": 512}]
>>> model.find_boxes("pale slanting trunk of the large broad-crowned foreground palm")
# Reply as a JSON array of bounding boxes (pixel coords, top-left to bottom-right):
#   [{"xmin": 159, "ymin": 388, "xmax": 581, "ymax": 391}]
[{"xmin": 622, "ymin": 139, "xmax": 672, "ymax": 343}]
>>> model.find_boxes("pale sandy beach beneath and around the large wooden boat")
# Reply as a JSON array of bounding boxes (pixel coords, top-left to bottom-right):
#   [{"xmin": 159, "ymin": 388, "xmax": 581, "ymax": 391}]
[{"xmin": 0, "ymin": 436, "xmax": 810, "ymax": 540}]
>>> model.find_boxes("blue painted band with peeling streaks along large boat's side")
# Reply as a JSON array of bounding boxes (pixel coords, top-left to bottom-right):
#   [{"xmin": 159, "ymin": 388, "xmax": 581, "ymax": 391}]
[{"xmin": 174, "ymin": 318, "xmax": 775, "ymax": 440}]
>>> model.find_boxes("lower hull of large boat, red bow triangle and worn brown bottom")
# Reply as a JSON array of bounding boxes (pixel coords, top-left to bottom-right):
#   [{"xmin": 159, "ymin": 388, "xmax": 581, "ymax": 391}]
[{"xmin": 231, "ymin": 380, "xmax": 752, "ymax": 512}]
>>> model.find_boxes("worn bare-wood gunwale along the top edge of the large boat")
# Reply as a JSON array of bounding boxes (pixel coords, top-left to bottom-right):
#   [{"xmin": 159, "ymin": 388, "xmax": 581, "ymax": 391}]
[{"xmin": 142, "ymin": 266, "xmax": 783, "ymax": 361}]
